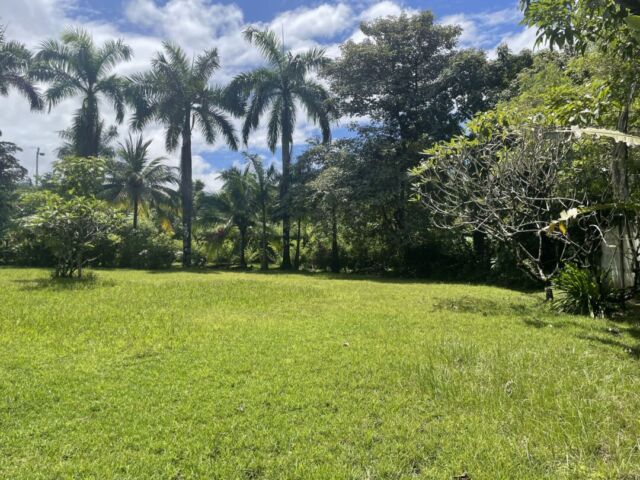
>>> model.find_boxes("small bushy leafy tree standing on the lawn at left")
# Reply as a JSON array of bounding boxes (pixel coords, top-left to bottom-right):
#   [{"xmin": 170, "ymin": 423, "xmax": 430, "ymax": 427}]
[{"xmin": 24, "ymin": 193, "xmax": 123, "ymax": 278}]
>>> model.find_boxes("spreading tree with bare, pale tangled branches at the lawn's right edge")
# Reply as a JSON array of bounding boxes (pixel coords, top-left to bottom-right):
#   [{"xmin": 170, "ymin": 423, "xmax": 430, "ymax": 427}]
[{"xmin": 414, "ymin": 129, "xmax": 610, "ymax": 282}]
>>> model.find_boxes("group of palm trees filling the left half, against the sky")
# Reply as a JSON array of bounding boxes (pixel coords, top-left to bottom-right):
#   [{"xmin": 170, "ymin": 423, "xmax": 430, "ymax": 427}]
[{"xmin": 0, "ymin": 28, "xmax": 333, "ymax": 269}]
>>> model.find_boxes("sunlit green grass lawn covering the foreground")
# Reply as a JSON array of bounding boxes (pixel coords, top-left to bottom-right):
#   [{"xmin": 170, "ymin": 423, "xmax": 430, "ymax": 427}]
[{"xmin": 0, "ymin": 269, "xmax": 640, "ymax": 480}]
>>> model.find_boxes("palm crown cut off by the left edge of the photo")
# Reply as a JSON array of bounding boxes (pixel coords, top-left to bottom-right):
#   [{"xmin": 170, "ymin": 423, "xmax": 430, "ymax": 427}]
[{"xmin": 0, "ymin": 26, "xmax": 43, "ymax": 110}]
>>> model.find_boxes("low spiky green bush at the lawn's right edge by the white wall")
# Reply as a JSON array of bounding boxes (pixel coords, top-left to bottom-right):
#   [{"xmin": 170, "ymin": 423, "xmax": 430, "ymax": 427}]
[{"xmin": 553, "ymin": 264, "xmax": 614, "ymax": 318}]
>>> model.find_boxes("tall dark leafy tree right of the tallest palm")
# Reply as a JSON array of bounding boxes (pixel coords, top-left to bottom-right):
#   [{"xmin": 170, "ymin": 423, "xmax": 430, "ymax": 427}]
[{"xmin": 323, "ymin": 11, "xmax": 532, "ymax": 269}]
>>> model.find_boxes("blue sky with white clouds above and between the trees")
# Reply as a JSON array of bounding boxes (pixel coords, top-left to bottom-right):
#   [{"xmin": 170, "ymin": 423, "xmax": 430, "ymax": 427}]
[{"xmin": 0, "ymin": 0, "xmax": 534, "ymax": 189}]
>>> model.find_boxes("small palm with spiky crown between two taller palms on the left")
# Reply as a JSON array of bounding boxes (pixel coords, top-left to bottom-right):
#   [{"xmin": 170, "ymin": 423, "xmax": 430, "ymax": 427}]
[{"xmin": 104, "ymin": 135, "xmax": 178, "ymax": 228}]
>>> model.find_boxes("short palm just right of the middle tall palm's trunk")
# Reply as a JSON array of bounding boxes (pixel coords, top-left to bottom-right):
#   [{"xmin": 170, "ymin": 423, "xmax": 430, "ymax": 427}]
[{"xmin": 203, "ymin": 166, "xmax": 258, "ymax": 268}]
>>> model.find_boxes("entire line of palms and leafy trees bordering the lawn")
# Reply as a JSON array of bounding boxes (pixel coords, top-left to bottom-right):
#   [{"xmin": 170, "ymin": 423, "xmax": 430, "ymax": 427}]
[{"xmin": 0, "ymin": 1, "xmax": 639, "ymax": 306}]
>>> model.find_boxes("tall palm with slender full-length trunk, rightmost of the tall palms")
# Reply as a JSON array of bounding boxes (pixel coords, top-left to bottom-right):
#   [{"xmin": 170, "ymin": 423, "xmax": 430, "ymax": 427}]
[{"xmin": 227, "ymin": 27, "xmax": 331, "ymax": 270}]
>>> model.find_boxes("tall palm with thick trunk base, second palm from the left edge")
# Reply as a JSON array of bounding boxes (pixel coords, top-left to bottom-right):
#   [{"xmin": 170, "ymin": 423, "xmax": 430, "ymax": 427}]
[{"xmin": 34, "ymin": 29, "xmax": 132, "ymax": 157}]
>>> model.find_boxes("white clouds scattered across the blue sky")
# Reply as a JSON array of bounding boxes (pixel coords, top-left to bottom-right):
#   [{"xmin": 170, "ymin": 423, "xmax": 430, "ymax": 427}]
[{"xmin": 0, "ymin": 0, "xmax": 531, "ymax": 189}]
